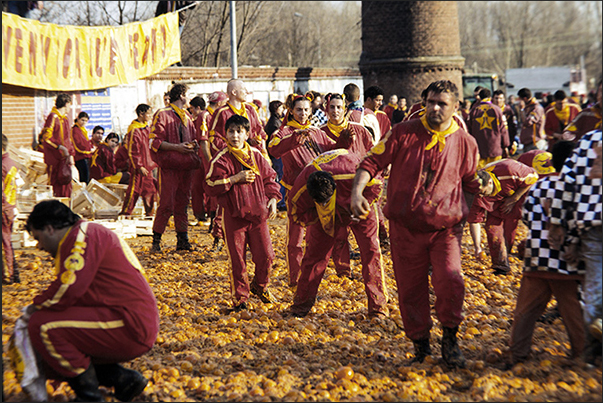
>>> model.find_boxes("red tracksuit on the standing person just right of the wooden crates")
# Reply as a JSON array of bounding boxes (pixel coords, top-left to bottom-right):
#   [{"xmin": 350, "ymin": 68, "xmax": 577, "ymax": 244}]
[{"xmin": 121, "ymin": 120, "xmax": 157, "ymax": 215}]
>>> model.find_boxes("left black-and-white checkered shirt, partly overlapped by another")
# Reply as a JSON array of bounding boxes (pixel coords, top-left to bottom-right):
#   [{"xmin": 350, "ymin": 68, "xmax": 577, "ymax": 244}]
[{"xmin": 523, "ymin": 175, "xmax": 584, "ymax": 274}]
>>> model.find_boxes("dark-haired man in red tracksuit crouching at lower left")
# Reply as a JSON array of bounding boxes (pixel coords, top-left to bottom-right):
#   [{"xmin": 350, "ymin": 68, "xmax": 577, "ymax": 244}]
[{"xmin": 24, "ymin": 200, "xmax": 159, "ymax": 402}]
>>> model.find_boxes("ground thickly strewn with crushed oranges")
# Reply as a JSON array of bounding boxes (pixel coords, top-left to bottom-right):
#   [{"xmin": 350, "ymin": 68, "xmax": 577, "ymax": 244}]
[{"xmin": 2, "ymin": 213, "xmax": 602, "ymax": 402}]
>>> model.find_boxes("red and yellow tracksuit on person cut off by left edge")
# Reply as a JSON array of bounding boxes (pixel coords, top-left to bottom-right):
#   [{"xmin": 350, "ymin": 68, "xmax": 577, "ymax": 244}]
[{"xmin": 2, "ymin": 152, "xmax": 18, "ymax": 284}]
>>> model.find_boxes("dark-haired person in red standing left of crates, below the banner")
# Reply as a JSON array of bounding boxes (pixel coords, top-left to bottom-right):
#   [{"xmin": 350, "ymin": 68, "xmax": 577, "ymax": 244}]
[{"xmin": 40, "ymin": 93, "xmax": 75, "ymax": 197}]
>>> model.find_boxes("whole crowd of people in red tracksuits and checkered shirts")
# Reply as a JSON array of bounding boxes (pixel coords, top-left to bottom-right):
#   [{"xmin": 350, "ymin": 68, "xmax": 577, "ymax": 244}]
[{"xmin": 2, "ymin": 79, "xmax": 602, "ymax": 401}]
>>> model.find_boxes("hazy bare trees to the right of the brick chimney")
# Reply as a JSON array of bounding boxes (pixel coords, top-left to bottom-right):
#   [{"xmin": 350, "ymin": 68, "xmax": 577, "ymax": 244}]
[{"xmin": 458, "ymin": 1, "xmax": 601, "ymax": 89}]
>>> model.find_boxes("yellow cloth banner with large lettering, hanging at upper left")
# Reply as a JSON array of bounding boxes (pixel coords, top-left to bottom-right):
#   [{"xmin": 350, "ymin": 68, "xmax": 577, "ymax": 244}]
[{"xmin": 2, "ymin": 13, "xmax": 180, "ymax": 91}]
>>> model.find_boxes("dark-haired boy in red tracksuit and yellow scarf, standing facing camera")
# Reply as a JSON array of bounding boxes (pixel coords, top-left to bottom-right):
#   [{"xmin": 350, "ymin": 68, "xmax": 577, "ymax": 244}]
[{"xmin": 207, "ymin": 115, "xmax": 281, "ymax": 311}]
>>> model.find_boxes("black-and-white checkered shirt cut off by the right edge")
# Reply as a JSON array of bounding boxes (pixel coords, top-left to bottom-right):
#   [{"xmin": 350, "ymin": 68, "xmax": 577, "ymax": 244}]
[{"xmin": 550, "ymin": 129, "xmax": 601, "ymax": 232}]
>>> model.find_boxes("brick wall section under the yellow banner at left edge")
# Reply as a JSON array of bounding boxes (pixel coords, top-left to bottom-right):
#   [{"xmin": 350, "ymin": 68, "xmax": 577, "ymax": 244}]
[{"xmin": 2, "ymin": 84, "xmax": 36, "ymax": 147}]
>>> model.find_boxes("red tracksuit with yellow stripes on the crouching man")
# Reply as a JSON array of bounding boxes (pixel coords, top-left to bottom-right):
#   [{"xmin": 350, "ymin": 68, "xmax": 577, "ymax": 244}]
[{"xmin": 29, "ymin": 220, "xmax": 159, "ymax": 378}]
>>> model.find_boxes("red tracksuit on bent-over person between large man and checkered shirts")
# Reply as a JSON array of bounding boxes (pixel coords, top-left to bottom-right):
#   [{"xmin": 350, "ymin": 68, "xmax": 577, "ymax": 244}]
[{"xmin": 467, "ymin": 158, "xmax": 538, "ymax": 272}]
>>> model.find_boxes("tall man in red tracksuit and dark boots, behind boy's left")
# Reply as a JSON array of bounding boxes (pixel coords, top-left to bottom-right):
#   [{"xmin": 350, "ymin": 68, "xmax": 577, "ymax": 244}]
[{"xmin": 149, "ymin": 83, "xmax": 201, "ymax": 252}]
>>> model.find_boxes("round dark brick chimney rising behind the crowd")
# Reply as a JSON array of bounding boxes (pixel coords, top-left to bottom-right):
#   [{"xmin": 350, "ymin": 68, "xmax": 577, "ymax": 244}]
[{"xmin": 358, "ymin": 1, "xmax": 465, "ymax": 106}]
